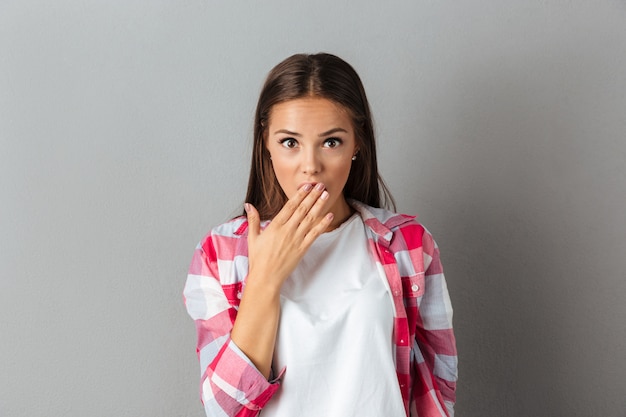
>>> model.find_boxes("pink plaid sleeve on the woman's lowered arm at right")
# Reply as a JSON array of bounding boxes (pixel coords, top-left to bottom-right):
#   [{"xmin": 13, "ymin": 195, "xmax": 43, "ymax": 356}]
[{"xmin": 416, "ymin": 230, "xmax": 458, "ymax": 417}]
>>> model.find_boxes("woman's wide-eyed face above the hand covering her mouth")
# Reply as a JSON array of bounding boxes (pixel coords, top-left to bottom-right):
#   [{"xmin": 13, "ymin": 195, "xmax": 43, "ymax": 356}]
[{"xmin": 265, "ymin": 98, "xmax": 358, "ymax": 226}]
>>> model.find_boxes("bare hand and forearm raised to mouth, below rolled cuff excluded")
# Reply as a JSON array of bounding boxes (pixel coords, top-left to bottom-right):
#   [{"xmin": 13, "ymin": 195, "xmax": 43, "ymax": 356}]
[{"xmin": 231, "ymin": 184, "xmax": 333, "ymax": 378}]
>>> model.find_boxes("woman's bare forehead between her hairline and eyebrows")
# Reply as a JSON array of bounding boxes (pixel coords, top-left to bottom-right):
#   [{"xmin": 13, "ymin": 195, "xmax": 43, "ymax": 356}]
[{"xmin": 269, "ymin": 97, "xmax": 352, "ymax": 127}]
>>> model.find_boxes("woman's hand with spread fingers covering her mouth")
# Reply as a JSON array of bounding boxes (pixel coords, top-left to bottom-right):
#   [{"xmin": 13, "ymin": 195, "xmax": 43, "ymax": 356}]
[{"xmin": 245, "ymin": 183, "xmax": 333, "ymax": 290}]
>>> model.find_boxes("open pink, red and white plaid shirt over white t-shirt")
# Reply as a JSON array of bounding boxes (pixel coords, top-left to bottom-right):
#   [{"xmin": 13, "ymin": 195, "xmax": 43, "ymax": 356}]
[{"xmin": 184, "ymin": 201, "xmax": 457, "ymax": 417}]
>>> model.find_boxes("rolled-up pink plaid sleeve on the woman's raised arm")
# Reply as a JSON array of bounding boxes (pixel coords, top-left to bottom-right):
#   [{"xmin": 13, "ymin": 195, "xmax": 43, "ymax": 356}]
[{"xmin": 183, "ymin": 236, "xmax": 279, "ymax": 417}]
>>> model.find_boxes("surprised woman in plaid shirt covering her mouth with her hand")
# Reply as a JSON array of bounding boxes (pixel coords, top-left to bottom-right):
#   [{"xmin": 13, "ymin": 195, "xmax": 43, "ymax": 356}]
[{"xmin": 184, "ymin": 54, "xmax": 457, "ymax": 417}]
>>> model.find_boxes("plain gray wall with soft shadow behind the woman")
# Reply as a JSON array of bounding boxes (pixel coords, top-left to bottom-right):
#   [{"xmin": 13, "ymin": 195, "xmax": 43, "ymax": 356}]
[{"xmin": 0, "ymin": 0, "xmax": 626, "ymax": 417}]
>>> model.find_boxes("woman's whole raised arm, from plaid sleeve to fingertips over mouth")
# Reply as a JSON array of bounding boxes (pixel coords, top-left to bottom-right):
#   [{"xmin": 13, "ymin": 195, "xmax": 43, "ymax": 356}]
[{"xmin": 185, "ymin": 186, "xmax": 333, "ymax": 416}]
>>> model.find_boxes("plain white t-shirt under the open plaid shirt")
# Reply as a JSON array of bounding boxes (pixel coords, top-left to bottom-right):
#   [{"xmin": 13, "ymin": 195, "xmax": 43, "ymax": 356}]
[{"xmin": 261, "ymin": 214, "xmax": 406, "ymax": 417}]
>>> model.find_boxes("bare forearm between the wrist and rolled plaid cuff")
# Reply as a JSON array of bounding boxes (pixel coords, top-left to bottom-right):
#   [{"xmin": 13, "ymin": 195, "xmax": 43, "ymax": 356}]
[{"xmin": 231, "ymin": 276, "xmax": 280, "ymax": 378}]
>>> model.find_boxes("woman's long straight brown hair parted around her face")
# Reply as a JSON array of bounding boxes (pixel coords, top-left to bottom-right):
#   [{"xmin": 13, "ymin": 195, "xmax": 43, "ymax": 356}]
[{"xmin": 241, "ymin": 53, "xmax": 395, "ymax": 219}]
